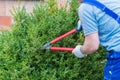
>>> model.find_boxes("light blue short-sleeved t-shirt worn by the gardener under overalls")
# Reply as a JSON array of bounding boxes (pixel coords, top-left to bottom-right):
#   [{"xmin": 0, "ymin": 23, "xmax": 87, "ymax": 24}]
[{"xmin": 78, "ymin": 0, "xmax": 120, "ymax": 51}]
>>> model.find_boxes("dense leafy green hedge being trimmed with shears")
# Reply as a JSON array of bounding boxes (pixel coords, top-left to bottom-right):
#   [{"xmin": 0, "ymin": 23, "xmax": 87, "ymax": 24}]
[{"xmin": 0, "ymin": 0, "xmax": 106, "ymax": 80}]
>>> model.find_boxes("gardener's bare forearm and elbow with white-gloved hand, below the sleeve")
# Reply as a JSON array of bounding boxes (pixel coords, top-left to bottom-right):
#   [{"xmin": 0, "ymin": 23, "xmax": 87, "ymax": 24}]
[{"xmin": 72, "ymin": 32, "xmax": 100, "ymax": 58}]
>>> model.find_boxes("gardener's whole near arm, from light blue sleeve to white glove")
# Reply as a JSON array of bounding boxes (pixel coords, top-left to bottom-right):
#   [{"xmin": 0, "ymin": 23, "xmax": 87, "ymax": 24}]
[{"xmin": 72, "ymin": 4, "xmax": 100, "ymax": 58}]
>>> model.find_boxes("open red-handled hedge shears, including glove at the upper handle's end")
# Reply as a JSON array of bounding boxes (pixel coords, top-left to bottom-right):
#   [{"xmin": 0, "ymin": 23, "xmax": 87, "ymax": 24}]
[{"xmin": 43, "ymin": 20, "xmax": 82, "ymax": 52}]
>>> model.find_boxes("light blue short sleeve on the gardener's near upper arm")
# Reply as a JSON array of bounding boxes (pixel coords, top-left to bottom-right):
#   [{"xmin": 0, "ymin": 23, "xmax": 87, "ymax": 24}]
[{"xmin": 78, "ymin": 3, "xmax": 98, "ymax": 36}]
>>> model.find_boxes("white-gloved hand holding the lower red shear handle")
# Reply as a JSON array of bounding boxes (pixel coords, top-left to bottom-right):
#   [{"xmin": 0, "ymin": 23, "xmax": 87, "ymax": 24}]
[{"xmin": 72, "ymin": 45, "xmax": 87, "ymax": 58}]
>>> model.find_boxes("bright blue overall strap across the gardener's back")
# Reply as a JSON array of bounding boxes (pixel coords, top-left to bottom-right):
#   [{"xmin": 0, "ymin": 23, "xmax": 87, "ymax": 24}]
[{"xmin": 82, "ymin": 0, "xmax": 120, "ymax": 24}]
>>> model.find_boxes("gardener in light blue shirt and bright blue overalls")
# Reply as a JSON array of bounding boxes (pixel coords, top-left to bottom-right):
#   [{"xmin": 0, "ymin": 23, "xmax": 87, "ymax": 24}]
[{"xmin": 72, "ymin": 0, "xmax": 120, "ymax": 80}]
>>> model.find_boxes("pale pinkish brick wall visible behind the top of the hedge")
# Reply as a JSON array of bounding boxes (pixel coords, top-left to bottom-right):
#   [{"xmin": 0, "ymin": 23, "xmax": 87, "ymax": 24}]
[{"xmin": 0, "ymin": 0, "xmax": 69, "ymax": 31}]
